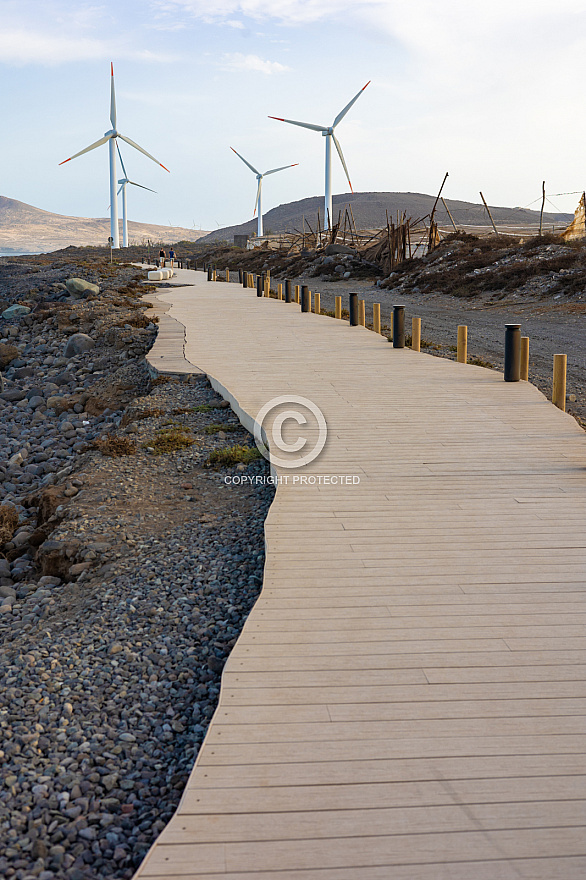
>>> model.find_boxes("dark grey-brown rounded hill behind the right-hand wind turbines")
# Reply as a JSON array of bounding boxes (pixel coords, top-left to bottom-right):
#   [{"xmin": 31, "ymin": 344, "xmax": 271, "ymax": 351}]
[{"xmin": 202, "ymin": 193, "xmax": 573, "ymax": 242}]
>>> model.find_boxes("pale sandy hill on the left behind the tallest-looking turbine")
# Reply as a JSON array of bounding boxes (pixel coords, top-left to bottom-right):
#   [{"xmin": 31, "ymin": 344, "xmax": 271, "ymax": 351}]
[{"xmin": 0, "ymin": 196, "xmax": 207, "ymax": 254}]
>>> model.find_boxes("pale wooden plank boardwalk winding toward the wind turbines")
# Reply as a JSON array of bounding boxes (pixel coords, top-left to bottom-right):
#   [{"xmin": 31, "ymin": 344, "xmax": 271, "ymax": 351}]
[{"xmin": 136, "ymin": 272, "xmax": 586, "ymax": 880}]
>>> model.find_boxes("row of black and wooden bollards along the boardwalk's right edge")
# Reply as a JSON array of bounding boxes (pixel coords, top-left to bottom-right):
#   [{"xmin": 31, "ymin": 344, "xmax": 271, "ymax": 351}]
[{"xmin": 205, "ymin": 261, "xmax": 568, "ymax": 412}]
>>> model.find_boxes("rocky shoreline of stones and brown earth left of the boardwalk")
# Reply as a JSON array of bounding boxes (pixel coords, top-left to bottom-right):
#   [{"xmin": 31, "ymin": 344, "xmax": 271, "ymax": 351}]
[{"xmin": 0, "ymin": 255, "xmax": 273, "ymax": 880}]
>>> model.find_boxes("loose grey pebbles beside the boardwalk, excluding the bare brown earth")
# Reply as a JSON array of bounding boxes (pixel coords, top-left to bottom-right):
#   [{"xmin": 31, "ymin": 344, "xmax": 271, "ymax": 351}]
[{"xmin": 0, "ymin": 254, "xmax": 272, "ymax": 880}]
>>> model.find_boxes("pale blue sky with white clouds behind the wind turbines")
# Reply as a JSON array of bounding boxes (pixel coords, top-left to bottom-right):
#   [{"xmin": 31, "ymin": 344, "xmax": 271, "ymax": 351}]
[{"xmin": 0, "ymin": 0, "xmax": 586, "ymax": 230}]
